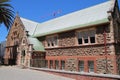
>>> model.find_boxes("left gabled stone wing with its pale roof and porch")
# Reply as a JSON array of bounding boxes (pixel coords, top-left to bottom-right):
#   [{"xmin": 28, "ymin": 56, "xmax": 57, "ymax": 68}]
[{"xmin": 4, "ymin": 15, "xmax": 45, "ymax": 66}]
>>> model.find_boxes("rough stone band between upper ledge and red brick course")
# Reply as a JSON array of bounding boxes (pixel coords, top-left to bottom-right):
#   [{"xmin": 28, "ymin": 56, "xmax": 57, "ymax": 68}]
[{"xmin": 46, "ymin": 45, "xmax": 115, "ymax": 56}]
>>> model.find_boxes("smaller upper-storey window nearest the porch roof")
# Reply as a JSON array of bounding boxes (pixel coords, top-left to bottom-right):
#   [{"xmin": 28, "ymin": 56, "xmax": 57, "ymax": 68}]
[{"xmin": 47, "ymin": 36, "xmax": 58, "ymax": 47}]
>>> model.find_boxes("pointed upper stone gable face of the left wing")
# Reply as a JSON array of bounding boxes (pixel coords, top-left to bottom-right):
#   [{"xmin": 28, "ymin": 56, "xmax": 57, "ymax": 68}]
[{"xmin": 6, "ymin": 16, "xmax": 24, "ymax": 46}]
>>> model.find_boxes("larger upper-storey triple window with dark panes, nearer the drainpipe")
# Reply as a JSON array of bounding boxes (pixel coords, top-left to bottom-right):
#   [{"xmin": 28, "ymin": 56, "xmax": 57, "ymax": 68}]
[{"xmin": 78, "ymin": 30, "xmax": 95, "ymax": 44}]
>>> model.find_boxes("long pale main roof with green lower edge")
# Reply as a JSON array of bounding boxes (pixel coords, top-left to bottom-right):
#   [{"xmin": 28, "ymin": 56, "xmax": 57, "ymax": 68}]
[{"xmin": 34, "ymin": 0, "xmax": 113, "ymax": 37}]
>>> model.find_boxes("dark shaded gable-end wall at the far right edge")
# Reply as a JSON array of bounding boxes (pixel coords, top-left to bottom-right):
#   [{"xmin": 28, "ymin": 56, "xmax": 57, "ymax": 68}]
[{"xmin": 112, "ymin": 0, "xmax": 120, "ymax": 74}]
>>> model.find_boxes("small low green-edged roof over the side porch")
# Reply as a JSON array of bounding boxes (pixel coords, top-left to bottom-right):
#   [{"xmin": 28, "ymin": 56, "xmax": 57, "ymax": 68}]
[{"xmin": 28, "ymin": 37, "xmax": 45, "ymax": 52}]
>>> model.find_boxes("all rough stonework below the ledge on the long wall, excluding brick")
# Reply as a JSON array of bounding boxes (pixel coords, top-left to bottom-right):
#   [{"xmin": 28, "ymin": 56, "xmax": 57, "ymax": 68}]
[{"xmin": 46, "ymin": 45, "xmax": 115, "ymax": 74}]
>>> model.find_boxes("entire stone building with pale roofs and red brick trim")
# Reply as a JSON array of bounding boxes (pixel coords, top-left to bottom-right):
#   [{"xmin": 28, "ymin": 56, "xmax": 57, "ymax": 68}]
[{"xmin": 5, "ymin": 0, "xmax": 120, "ymax": 74}]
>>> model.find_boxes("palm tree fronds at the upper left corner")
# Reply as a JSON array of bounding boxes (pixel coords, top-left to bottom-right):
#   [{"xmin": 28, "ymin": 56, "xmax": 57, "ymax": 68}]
[{"xmin": 0, "ymin": 0, "xmax": 14, "ymax": 29}]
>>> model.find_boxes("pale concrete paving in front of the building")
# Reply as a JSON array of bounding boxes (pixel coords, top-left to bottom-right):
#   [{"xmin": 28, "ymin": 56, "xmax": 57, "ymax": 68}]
[{"xmin": 0, "ymin": 66, "xmax": 74, "ymax": 80}]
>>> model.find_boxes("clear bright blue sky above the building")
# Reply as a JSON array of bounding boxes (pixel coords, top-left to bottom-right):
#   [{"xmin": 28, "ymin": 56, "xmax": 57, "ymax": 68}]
[{"xmin": 0, "ymin": 0, "xmax": 120, "ymax": 42}]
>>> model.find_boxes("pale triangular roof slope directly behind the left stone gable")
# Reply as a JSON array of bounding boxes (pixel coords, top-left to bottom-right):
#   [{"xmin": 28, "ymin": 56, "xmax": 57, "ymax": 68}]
[{"xmin": 20, "ymin": 17, "xmax": 39, "ymax": 36}]
